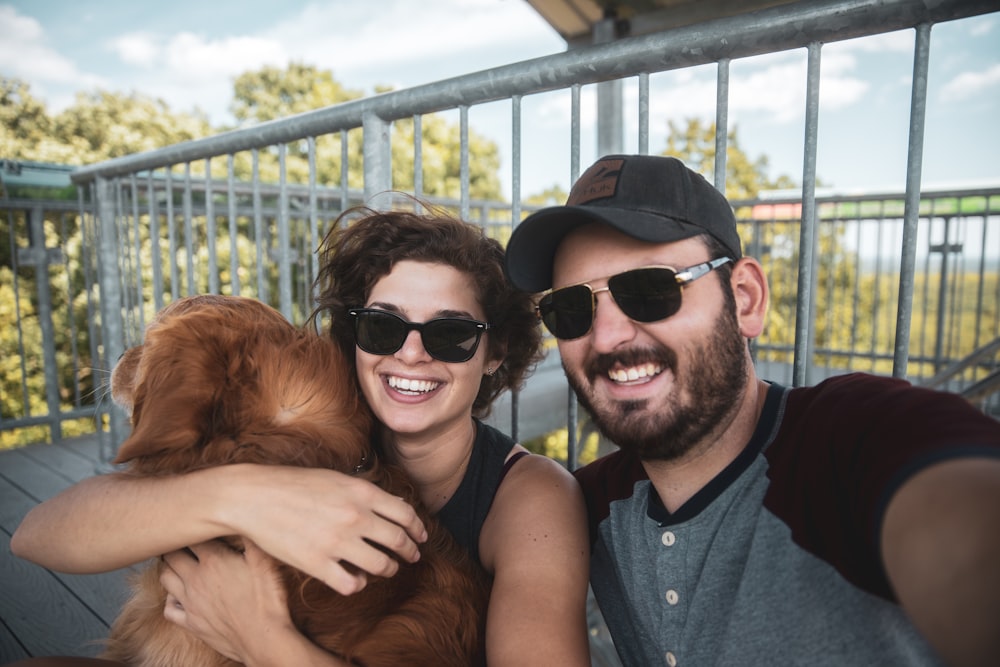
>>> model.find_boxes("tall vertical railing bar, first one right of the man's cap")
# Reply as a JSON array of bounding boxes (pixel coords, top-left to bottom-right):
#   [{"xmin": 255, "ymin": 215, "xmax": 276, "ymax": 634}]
[{"xmin": 792, "ymin": 42, "xmax": 822, "ymax": 386}]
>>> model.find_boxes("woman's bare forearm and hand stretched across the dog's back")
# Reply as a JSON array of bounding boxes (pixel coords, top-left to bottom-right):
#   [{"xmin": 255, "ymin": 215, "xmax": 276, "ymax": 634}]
[{"xmin": 11, "ymin": 465, "xmax": 426, "ymax": 594}]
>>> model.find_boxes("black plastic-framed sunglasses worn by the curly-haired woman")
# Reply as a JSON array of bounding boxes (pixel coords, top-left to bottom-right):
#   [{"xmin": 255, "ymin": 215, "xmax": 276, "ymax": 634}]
[{"xmin": 347, "ymin": 308, "xmax": 490, "ymax": 364}]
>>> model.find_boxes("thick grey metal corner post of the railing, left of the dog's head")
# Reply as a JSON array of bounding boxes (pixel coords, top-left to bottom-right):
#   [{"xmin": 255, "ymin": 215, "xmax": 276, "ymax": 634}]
[{"xmin": 94, "ymin": 176, "xmax": 128, "ymax": 464}]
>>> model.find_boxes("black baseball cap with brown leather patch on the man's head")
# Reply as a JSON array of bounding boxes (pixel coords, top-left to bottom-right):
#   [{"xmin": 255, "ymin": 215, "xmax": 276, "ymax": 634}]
[{"xmin": 506, "ymin": 155, "xmax": 743, "ymax": 292}]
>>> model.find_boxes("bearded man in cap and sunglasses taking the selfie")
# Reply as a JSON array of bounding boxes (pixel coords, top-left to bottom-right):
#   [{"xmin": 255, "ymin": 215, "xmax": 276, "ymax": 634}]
[{"xmin": 507, "ymin": 156, "xmax": 1000, "ymax": 667}]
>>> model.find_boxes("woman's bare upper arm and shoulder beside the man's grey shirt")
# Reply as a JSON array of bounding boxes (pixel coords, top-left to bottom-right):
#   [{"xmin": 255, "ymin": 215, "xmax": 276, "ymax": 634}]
[{"xmin": 480, "ymin": 456, "xmax": 590, "ymax": 667}]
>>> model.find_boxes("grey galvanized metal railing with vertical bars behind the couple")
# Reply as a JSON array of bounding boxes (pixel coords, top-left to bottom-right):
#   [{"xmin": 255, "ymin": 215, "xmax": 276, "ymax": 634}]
[{"xmin": 0, "ymin": 0, "xmax": 1000, "ymax": 457}]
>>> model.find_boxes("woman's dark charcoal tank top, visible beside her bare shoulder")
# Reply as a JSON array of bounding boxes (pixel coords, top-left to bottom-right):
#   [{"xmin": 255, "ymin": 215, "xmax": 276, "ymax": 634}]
[{"xmin": 437, "ymin": 419, "xmax": 527, "ymax": 563}]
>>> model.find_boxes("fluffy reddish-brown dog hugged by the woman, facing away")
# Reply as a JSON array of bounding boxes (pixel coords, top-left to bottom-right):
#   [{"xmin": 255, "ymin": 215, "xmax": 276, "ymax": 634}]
[{"xmin": 103, "ymin": 296, "xmax": 488, "ymax": 667}]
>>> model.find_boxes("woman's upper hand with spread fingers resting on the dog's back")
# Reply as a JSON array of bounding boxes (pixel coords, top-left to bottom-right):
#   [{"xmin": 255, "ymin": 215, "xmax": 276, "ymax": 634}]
[{"xmin": 219, "ymin": 466, "xmax": 427, "ymax": 595}]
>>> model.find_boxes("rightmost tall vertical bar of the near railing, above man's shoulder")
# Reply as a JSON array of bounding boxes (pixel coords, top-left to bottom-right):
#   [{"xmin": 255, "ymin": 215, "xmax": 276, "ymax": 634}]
[{"xmin": 892, "ymin": 23, "xmax": 932, "ymax": 378}]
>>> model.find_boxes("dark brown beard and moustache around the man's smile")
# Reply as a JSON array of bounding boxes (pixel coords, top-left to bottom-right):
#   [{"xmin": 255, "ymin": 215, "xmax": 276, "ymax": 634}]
[{"xmin": 564, "ymin": 304, "xmax": 748, "ymax": 461}]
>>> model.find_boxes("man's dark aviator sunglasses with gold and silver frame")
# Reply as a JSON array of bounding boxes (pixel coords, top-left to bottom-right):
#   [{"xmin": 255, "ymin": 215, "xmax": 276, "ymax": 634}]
[{"xmin": 538, "ymin": 257, "xmax": 733, "ymax": 340}]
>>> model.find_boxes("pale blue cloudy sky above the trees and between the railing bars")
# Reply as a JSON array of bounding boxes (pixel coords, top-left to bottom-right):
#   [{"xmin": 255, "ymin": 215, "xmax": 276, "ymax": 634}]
[{"xmin": 0, "ymin": 0, "xmax": 1000, "ymax": 194}]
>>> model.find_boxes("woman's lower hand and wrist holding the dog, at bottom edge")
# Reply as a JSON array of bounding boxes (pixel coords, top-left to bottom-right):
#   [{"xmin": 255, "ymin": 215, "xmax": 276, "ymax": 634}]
[{"xmin": 160, "ymin": 542, "xmax": 348, "ymax": 667}]
